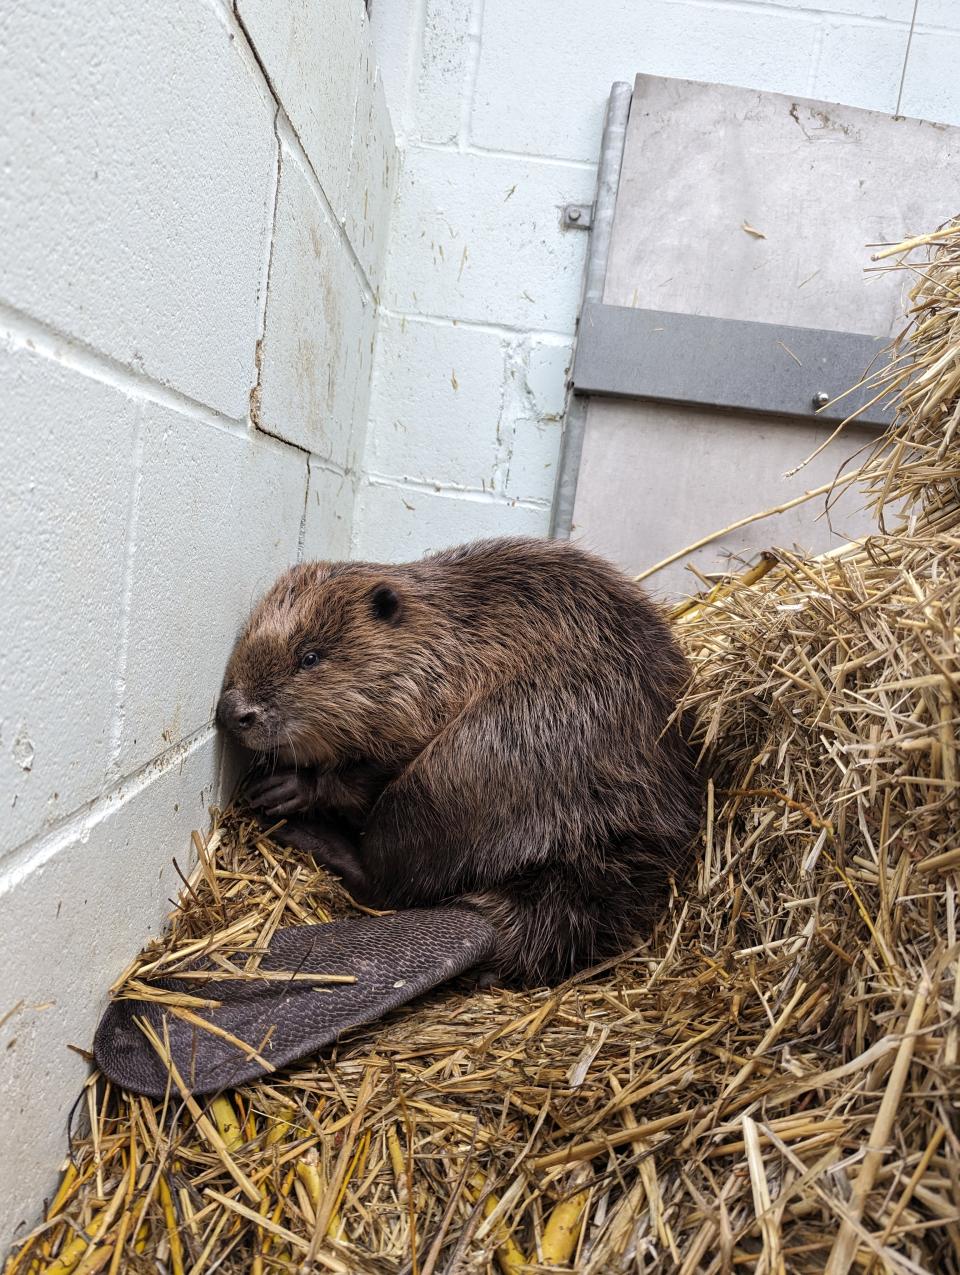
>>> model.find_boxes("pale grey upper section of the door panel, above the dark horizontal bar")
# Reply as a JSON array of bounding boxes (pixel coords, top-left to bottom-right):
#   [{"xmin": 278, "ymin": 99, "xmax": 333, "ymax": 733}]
[{"xmin": 603, "ymin": 75, "xmax": 960, "ymax": 335}]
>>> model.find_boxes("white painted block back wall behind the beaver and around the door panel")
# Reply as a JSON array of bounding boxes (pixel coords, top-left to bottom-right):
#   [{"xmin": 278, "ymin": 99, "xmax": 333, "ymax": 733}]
[{"xmin": 354, "ymin": 0, "xmax": 960, "ymax": 560}]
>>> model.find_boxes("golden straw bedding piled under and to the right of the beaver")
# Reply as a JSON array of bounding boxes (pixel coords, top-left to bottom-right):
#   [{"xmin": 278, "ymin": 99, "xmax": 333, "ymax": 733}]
[{"xmin": 6, "ymin": 226, "xmax": 960, "ymax": 1275}]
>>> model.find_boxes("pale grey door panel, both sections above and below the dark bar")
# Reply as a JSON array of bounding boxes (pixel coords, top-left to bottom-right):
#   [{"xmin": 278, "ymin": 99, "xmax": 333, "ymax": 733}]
[{"xmin": 574, "ymin": 75, "xmax": 960, "ymax": 597}]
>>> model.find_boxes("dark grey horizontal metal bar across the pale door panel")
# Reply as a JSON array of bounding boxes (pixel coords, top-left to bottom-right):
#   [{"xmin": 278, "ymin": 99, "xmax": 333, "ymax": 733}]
[{"xmin": 572, "ymin": 301, "xmax": 890, "ymax": 428}]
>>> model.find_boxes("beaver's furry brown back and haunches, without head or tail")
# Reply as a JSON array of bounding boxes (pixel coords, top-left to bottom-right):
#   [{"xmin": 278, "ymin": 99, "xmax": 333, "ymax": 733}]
[{"xmin": 365, "ymin": 539, "xmax": 700, "ymax": 982}]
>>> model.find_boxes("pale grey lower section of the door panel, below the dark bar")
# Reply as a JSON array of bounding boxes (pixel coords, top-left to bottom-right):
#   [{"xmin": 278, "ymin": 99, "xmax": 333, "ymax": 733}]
[{"xmin": 572, "ymin": 399, "xmax": 876, "ymax": 599}]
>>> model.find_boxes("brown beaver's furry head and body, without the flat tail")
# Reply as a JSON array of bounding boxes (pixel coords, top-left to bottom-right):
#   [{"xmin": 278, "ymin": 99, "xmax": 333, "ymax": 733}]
[{"xmin": 217, "ymin": 538, "xmax": 701, "ymax": 986}]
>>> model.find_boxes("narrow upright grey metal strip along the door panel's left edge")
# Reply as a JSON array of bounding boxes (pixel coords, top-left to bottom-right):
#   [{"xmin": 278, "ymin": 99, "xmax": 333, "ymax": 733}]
[{"xmin": 549, "ymin": 80, "xmax": 634, "ymax": 541}]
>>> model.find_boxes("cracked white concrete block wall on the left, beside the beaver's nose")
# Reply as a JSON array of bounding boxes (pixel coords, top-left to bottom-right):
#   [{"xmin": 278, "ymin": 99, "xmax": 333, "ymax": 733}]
[{"xmin": 0, "ymin": 0, "xmax": 396, "ymax": 1253}]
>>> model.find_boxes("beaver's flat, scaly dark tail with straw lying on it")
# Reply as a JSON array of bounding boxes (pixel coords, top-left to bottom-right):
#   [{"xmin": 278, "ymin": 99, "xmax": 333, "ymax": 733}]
[{"xmin": 93, "ymin": 908, "xmax": 495, "ymax": 1098}]
